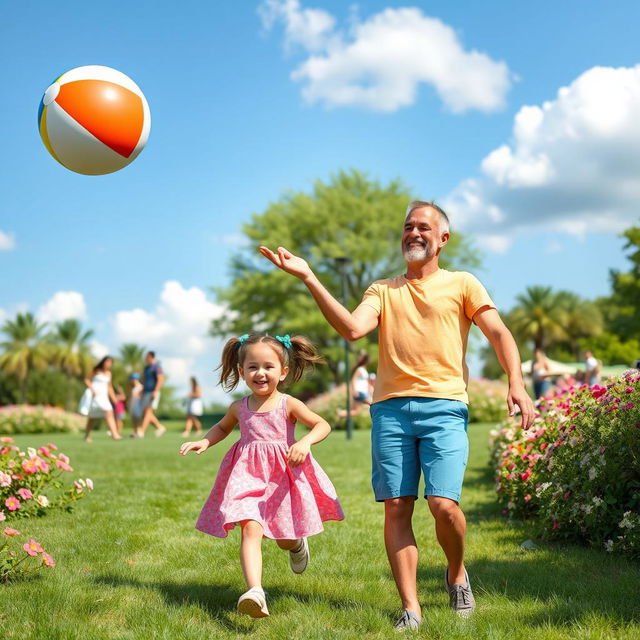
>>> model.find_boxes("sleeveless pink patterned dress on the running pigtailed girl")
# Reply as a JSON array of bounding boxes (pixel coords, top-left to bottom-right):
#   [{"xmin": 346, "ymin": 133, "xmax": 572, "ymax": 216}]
[{"xmin": 196, "ymin": 394, "xmax": 344, "ymax": 540}]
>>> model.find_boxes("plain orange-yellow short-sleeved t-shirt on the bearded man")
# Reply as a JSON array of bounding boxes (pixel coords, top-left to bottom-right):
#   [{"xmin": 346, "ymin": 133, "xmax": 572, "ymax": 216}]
[{"xmin": 362, "ymin": 269, "xmax": 495, "ymax": 403}]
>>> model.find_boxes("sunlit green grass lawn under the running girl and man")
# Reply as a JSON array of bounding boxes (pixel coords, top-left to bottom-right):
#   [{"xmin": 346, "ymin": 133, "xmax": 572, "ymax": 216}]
[{"xmin": 0, "ymin": 424, "xmax": 640, "ymax": 640}]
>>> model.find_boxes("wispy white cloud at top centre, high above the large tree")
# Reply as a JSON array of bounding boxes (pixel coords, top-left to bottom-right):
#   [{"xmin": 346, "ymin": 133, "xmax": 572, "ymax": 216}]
[{"xmin": 259, "ymin": 0, "xmax": 511, "ymax": 113}]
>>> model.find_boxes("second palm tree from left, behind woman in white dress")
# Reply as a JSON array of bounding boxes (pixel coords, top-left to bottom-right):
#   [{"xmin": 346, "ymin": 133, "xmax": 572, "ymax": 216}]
[{"xmin": 48, "ymin": 318, "xmax": 94, "ymax": 410}]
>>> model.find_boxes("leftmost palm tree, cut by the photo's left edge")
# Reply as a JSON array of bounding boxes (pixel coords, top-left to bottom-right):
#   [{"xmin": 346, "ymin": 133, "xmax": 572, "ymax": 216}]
[{"xmin": 0, "ymin": 312, "xmax": 52, "ymax": 403}]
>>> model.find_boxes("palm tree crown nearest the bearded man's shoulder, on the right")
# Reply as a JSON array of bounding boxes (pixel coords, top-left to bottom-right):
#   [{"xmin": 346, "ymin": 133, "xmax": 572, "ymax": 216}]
[{"xmin": 507, "ymin": 286, "xmax": 566, "ymax": 349}]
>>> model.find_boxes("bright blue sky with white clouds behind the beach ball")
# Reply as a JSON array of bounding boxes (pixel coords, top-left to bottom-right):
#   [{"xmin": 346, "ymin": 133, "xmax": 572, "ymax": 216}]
[{"xmin": 0, "ymin": 0, "xmax": 640, "ymax": 397}]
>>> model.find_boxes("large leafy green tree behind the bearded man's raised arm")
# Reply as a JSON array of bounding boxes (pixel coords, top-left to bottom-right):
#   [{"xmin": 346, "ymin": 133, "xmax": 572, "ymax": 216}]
[{"xmin": 211, "ymin": 170, "xmax": 479, "ymax": 390}]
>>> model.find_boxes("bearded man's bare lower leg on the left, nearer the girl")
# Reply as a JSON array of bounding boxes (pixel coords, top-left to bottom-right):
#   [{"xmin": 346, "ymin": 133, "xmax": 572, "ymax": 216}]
[{"xmin": 384, "ymin": 496, "xmax": 421, "ymax": 617}]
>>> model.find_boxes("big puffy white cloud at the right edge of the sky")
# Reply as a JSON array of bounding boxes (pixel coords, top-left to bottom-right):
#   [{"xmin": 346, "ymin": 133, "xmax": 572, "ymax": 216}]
[{"xmin": 443, "ymin": 65, "xmax": 640, "ymax": 236}]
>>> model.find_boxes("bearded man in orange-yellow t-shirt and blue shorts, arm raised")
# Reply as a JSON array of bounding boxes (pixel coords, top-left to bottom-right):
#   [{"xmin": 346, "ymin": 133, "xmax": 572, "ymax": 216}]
[{"xmin": 260, "ymin": 201, "xmax": 534, "ymax": 631}]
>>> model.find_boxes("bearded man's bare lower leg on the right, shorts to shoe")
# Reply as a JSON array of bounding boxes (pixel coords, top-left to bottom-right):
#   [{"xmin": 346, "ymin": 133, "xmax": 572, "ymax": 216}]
[{"xmin": 427, "ymin": 496, "xmax": 467, "ymax": 584}]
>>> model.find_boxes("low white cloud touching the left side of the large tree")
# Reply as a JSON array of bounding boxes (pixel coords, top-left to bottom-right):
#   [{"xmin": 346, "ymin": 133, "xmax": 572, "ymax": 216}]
[{"xmin": 111, "ymin": 280, "xmax": 226, "ymax": 400}]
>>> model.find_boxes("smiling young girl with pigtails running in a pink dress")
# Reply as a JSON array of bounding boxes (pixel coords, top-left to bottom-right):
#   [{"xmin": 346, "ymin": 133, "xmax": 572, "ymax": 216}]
[{"xmin": 180, "ymin": 334, "xmax": 344, "ymax": 618}]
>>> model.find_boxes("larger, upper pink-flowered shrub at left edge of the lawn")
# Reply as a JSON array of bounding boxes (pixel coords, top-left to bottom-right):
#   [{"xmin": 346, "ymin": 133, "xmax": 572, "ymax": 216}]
[{"xmin": 0, "ymin": 437, "xmax": 93, "ymax": 521}]
